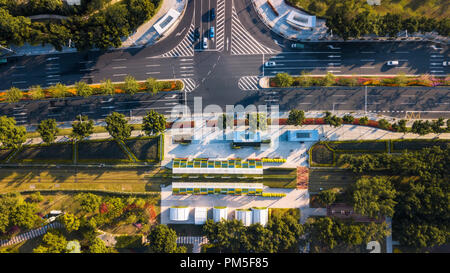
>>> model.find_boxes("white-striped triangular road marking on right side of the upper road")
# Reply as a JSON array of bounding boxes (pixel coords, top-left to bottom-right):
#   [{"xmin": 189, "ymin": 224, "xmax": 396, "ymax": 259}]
[{"xmin": 231, "ymin": 7, "xmax": 279, "ymax": 55}]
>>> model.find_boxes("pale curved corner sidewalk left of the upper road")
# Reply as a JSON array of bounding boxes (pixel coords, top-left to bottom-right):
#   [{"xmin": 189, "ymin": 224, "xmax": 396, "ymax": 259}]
[{"xmin": 122, "ymin": 0, "xmax": 187, "ymax": 47}]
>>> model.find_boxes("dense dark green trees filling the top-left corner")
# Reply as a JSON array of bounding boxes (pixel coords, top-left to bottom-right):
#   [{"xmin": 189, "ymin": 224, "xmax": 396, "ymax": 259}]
[{"xmin": 0, "ymin": 0, "xmax": 162, "ymax": 50}]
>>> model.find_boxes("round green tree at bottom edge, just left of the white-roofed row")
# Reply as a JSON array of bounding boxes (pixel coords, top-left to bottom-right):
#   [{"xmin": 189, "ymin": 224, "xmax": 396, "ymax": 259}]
[{"xmin": 147, "ymin": 225, "xmax": 185, "ymax": 253}]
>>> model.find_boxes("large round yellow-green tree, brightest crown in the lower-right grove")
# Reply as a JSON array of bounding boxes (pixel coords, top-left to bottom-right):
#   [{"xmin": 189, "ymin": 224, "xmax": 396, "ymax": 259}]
[{"xmin": 352, "ymin": 177, "xmax": 397, "ymax": 218}]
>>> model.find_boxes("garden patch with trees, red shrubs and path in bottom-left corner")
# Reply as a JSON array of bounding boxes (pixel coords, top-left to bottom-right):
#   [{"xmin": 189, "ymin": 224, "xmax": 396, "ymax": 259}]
[{"xmin": 0, "ymin": 192, "xmax": 169, "ymax": 253}]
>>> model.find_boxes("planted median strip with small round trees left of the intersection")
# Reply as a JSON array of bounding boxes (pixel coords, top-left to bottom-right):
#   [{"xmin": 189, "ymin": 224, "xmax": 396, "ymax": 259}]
[{"xmin": 0, "ymin": 76, "xmax": 183, "ymax": 103}]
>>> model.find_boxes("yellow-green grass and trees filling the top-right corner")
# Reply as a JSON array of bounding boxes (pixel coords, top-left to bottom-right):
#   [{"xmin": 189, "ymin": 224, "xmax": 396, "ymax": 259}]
[{"xmin": 287, "ymin": 0, "xmax": 450, "ymax": 39}]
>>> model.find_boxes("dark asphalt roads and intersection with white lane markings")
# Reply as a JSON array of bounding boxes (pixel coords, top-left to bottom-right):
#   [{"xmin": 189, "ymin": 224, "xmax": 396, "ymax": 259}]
[{"xmin": 0, "ymin": 0, "xmax": 450, "ymax": 124}]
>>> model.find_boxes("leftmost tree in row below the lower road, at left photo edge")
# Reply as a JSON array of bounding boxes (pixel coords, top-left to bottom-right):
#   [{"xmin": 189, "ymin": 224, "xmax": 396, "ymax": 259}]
[{"xmin": 0, "ymin": 116, "xmax": 27, "ymax": 149}]
